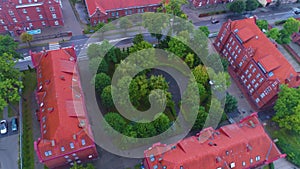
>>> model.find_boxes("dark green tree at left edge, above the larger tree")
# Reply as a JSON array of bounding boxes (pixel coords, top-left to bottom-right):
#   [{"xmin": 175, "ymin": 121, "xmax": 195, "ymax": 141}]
[{"xmin": 0, "ymin": 35, "xmax": 21, "ymax": 59}]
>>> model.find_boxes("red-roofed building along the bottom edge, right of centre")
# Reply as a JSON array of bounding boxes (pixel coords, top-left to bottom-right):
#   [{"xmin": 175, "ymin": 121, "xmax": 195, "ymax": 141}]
[{"xmin": 144, "ymin": 113, "xmax": 286, "ymax": 169}]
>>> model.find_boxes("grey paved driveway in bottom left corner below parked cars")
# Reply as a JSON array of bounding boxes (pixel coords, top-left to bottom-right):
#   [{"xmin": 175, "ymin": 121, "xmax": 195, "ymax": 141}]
[{"xmin": 0, "ymin": 134, "xmax": 19, "ymax": 169}]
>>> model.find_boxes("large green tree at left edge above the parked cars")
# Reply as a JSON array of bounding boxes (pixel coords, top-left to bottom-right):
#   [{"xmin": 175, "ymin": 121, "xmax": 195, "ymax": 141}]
[{"xmin": 0, "ymin": 53, "xmax": 23, "ymax": 111}]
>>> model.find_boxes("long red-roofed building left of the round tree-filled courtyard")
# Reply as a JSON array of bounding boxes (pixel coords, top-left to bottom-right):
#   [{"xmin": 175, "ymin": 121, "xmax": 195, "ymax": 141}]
[{"xmin": 31, "ymin": 47, "xmax": 98, "ymax": 168}]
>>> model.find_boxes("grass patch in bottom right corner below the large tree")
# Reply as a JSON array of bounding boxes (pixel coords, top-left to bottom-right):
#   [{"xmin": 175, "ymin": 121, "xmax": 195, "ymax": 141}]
[{"xmin": 266, "ymin": 125, "xmax": 300, "ymax": 167}]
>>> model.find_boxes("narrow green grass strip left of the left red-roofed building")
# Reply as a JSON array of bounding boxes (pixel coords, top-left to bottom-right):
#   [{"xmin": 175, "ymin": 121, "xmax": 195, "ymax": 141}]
[{"xmin": 22, "ymin": 71, "xmax": 36, "ymax": 168}]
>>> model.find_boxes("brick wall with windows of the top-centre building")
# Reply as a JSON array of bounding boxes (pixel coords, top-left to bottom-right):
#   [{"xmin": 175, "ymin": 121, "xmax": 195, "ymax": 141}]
[{"xmin": 90, "ymin": 5, "xmax": 160, "ymax": 25}]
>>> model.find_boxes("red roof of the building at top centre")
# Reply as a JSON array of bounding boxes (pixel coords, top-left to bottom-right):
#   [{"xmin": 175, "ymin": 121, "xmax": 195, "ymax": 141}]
[{"xmin": 85, "ymin": 0, "xmax": 161, "ymax": 16}]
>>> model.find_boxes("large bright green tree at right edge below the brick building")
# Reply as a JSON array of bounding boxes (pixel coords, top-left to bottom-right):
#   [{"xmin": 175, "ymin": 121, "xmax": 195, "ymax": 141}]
[{"xmin": 272, "ymin": 85, "xmax": 300, "ymax": 134}]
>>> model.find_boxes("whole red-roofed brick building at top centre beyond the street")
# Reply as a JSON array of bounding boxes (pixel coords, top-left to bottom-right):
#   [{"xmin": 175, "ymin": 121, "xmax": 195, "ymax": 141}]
[{"xmin": 85, "ymin": 0, "xmax": 162, "ymax": 25}]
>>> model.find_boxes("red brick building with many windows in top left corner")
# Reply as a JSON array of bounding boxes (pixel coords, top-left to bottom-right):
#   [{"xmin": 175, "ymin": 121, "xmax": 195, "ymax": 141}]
[{"xmin": 0, "ymin": 0, "xmax": 64, "ymax": 35}]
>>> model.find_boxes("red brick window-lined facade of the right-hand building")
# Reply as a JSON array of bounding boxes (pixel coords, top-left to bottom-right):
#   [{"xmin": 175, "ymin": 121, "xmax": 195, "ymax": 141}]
[{"xmin": 214, "ymin": 21, "xmax": 279, "ymax": 110}]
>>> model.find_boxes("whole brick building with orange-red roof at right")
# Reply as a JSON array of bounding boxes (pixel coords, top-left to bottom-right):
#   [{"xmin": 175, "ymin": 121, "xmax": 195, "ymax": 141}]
[{"xmin": 214, "ymin": 18, "xmax": 300, "ymax": 110}]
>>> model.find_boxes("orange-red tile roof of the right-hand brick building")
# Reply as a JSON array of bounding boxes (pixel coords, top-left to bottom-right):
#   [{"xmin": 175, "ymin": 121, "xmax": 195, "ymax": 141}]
[{"xmin": 230, "ymin": 18, "xmax": 300, "ymax": 87}]
